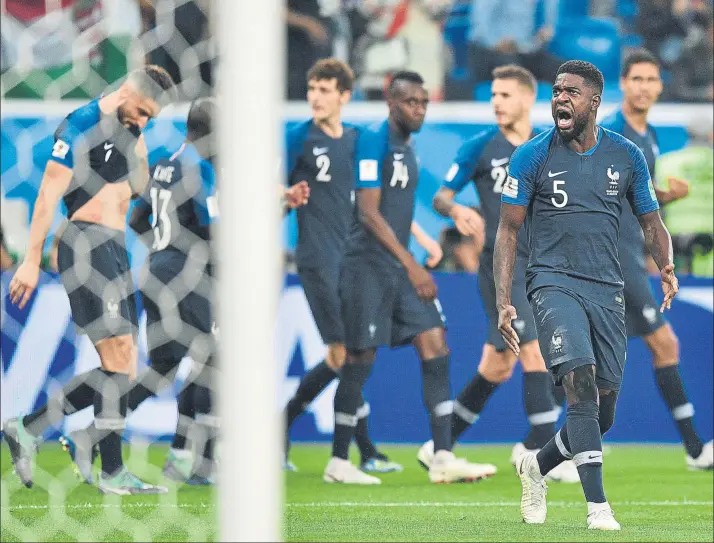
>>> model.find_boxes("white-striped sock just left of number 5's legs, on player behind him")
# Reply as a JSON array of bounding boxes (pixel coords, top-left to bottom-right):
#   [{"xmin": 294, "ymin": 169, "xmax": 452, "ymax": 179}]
[{"xmin": 523, "ymin": 371, "xmax": 560, "ymax": 449}]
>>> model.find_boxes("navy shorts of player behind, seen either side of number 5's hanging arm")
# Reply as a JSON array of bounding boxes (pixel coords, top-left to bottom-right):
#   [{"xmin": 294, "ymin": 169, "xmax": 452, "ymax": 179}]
[{"xmin": 478, "ymin": 251, "xmax": 538, "ymax": 352}]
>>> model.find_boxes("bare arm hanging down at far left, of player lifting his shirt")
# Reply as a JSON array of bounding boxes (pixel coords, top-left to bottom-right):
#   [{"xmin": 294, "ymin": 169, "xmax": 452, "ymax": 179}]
[{"xmin": 10, "ymin": 160, "xmax": 72, "ymax": 309}]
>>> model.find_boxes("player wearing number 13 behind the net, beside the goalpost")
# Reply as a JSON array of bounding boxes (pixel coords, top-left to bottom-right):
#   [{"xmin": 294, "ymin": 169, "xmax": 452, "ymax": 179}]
[{"xmin": 60, "ymin": 95, "xmax": 218, "ymax": 484}]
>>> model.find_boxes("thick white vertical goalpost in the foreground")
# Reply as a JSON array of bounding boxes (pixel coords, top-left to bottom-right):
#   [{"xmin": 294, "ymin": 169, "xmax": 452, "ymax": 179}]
[{"xmin": 216, "ymin": 0, "xmax": 284, "ymax": 541}]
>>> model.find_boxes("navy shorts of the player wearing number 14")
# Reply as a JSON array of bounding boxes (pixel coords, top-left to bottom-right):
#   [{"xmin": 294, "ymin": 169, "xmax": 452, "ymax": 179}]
[{"xmin": 340, "ymin": 262, "xmax": 446, "ymax": 351}]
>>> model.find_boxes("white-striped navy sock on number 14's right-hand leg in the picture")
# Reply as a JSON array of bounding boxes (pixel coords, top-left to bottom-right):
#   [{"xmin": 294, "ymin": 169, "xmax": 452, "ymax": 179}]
[{"xmin": 421, "ymin": 355, "xmax": 453, "ymax": 452}]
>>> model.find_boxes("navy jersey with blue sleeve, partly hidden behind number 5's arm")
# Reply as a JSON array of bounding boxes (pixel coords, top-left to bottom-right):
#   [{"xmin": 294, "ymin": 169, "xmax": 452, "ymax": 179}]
[{"xmin": 444, "ymin": 127, "xmax": 535, "ymax": 256}]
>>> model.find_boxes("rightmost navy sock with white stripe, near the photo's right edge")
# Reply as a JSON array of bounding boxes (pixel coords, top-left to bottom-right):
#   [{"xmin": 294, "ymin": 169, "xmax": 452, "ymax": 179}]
[{"xmin": 655, "ymin": 364, "xmax": 703, "ymax": 458}]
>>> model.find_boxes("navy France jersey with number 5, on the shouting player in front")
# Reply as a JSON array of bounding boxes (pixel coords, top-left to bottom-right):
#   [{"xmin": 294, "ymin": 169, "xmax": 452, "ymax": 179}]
[{"xmin": 501, "ymin": 128, "xmax": 659, "ymax": 309}]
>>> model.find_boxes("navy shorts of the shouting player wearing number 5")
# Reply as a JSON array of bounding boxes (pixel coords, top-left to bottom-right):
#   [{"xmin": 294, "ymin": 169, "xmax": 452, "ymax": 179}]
[{"xmin": 530, "ymin": 287, "xmax": 627, "ymax": 390}]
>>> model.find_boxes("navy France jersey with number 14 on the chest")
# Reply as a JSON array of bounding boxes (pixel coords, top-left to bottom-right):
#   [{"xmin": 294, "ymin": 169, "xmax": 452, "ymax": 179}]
[{"xmin": 347, "ymin": 121, "xmax": 419, "ymax": 267}]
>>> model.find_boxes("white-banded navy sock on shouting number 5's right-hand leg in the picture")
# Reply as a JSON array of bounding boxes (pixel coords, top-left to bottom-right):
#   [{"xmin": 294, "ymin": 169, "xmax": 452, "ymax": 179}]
[{"xmin": 565, "ymin": 400, "xmax": 607, "ymax": 504}]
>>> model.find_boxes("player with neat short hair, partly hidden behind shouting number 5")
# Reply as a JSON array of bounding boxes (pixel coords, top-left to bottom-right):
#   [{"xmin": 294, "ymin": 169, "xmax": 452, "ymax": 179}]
[{"xmin": 418, "ymin": 65, "xmax": 580, "ymax": 483}]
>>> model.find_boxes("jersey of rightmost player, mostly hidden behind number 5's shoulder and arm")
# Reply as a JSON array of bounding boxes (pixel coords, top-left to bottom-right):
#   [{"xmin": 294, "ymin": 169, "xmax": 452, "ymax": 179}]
[{"xmin": 600, "ymin": 109, "xmax": 659, "ymax": 267}]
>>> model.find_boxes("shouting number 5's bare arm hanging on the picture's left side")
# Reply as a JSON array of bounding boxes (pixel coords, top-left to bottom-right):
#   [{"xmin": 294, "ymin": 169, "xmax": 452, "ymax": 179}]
[{"xmin": 493, "ymin": 203, "xmax": 527, "ymax": 355}]
